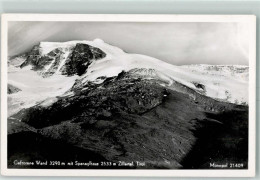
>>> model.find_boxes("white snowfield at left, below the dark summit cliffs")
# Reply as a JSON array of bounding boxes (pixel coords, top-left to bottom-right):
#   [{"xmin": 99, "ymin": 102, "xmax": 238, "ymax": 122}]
[{"xmin": 8, "ymin": 66, "xmax": 78, "ymax": 116}]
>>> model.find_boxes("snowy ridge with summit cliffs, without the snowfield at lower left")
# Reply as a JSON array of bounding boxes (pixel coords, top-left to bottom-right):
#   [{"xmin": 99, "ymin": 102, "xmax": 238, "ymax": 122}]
[{"xmin": 9, "ymin": 39, "xmax": 249, "ymax": 104}]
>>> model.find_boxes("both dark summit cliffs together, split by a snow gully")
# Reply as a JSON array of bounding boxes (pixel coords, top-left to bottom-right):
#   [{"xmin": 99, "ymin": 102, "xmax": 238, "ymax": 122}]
[{"xmin": 20, "ymin": 43, "xmax": 106, "ymax": 77}]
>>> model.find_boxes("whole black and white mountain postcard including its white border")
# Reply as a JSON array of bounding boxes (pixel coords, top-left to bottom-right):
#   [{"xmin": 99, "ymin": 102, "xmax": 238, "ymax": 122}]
[{"xmin": 1, "ymin": 15, "xmax": 255, "ymax": 176}]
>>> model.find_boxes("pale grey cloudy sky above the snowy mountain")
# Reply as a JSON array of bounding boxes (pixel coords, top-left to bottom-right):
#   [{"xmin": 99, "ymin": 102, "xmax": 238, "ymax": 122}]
[{"xmin": 8, "ymin": 21, "xmax": 249, "ymax": 65}]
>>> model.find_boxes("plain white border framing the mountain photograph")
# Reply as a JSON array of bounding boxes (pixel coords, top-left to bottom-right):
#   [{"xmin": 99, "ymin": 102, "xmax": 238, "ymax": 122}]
[{"xmin": 1, "ymin": 14, "xmax": 256, "ymax": 177}]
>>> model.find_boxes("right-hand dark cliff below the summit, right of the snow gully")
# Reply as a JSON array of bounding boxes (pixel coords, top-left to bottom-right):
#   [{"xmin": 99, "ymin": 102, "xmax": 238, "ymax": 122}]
[{"xmin": 62, "ymin": 43, "xmax": 106, "ymax": 76}]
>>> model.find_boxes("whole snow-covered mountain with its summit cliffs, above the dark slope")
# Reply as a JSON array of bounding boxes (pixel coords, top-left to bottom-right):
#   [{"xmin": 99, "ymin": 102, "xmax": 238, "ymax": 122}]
[{"xmin": 8, "ymin": 39, "xmax": 248, "ymax": 114}]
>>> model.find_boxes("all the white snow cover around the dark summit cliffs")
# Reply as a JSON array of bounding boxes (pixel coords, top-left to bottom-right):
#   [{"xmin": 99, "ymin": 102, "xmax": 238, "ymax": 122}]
[{"xmin": 8, "ymin": 39, "xmax": 248, "ymax": 115}]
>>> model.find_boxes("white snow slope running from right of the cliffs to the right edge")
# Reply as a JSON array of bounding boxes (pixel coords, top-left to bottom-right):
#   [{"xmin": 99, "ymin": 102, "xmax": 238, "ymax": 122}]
[{"xmin": 74, "ymin": 40, "xmax": 248, "ymax": 104}]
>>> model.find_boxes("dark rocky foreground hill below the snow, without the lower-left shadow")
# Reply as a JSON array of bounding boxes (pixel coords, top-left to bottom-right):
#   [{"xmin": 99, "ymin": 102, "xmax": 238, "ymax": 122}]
[{"xmin": 8, "ymin": 72, "xmax": 248, "ymax": 168}]
